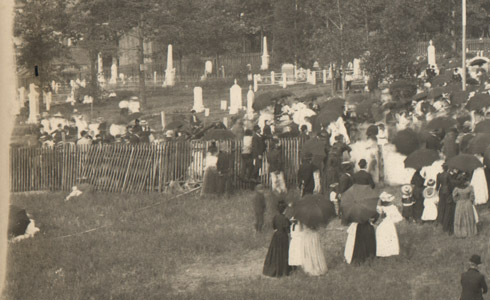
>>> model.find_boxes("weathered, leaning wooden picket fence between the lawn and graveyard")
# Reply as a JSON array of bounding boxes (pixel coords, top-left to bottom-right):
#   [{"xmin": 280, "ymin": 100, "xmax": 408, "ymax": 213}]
[{"xmin": 10, "ymin": 138, "xmax": 303, "ymax": 193}]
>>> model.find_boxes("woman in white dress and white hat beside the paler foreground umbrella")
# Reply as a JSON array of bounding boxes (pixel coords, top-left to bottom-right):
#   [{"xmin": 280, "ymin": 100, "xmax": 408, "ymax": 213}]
[{"xmin": 376, "ymin": 192, "xmax": 403, "ymax": 257}]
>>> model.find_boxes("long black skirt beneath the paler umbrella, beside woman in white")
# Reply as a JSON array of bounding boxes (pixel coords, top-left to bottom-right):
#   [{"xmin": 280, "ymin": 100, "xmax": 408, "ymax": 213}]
[{"xmin": 352, "ymin": 222, "xmax": 376, "ymax": 263}]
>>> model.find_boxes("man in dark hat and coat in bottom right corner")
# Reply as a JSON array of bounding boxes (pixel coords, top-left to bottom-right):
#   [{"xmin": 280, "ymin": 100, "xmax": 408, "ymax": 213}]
[{"xmin": 460, "ymin": 254, "xmax": 488, "ymax": 300}]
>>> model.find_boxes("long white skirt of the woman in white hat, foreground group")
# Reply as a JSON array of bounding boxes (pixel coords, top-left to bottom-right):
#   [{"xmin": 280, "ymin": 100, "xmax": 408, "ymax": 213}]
[{"xmin": 376, "ymin": 219, "xmax": 400, "ymax": 257}]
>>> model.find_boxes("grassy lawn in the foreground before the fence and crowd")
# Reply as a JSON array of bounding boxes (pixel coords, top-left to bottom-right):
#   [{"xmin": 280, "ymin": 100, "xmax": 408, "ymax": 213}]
[{"xmin": 3, "ymin": 188, "xmax": 490, "ymax": 300}]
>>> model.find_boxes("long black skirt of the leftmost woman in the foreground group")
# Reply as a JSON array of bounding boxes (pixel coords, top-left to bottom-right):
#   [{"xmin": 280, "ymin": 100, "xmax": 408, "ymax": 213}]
[{"xmin": 262, "ymin": 231, "xmax": 289, "ymax": 277}]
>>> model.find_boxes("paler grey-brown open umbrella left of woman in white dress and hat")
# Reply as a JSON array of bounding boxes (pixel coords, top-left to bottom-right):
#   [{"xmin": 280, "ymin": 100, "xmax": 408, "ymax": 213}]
[{"xmin": 340, "ymin": 184, "xmax": 379, "ymax": 223}]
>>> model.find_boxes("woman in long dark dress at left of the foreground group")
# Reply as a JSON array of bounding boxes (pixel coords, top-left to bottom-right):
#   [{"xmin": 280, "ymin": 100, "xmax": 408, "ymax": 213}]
[{"xmin": 262, "ymin": 202, "xmax": 290, "ymax": 277}]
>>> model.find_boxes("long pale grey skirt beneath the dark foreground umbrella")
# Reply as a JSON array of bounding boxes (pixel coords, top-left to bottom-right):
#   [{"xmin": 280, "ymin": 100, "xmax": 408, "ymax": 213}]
[{"xmin": 303, "ymin": 228, "xmax": 327, "ymax": 276}]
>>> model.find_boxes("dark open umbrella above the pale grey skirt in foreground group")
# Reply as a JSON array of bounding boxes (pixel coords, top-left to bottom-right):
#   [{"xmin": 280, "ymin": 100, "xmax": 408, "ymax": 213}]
[{"xmin": 293, "ymin": 195, "xmax": 335, "ymax": 229}]
